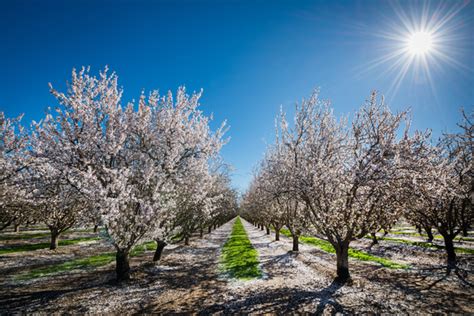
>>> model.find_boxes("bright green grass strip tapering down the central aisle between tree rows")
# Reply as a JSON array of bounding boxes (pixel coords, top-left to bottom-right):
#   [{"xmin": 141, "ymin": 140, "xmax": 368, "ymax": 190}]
[{"xmin": 221, "ymin": 217, "xmax": 262, "ymax": 280}]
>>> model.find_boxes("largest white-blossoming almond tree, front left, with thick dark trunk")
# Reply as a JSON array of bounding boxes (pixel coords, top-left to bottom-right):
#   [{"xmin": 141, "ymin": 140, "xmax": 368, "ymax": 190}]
[{"xmin": 36, "ymin": 68, "xmax": 224, "ymax": 280}]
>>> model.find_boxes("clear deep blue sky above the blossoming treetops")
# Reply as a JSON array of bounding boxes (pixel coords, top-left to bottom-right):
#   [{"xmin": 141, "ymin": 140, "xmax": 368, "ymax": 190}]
[{"xmin": 0, "ymin": 0, "xmax": 474, "ymax": 190}]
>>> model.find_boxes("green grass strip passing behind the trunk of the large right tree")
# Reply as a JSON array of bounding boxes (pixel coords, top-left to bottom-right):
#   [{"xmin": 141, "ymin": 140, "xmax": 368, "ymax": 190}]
[{"xmin": 280, "ymin": 228, "xmax": 410, "ymax": 269}]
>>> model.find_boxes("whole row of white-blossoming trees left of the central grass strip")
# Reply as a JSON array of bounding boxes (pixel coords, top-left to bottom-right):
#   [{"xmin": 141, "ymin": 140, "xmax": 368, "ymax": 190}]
[{"xmin": 0, "ymin": 68, "xmax": 237, "ymax": 280}]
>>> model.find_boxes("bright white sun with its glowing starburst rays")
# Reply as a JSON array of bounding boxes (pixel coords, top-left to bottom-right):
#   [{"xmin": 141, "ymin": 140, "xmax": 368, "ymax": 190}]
[{"xmin": 357, "ymin": 1, "xmax": 472, "ymax": 97}]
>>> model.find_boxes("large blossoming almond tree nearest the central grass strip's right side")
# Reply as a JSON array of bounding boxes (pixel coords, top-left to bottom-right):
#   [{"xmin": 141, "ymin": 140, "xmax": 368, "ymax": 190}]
[{"xmin": 280, "ymin": 93, "xmax": 408, "ymax": 281}]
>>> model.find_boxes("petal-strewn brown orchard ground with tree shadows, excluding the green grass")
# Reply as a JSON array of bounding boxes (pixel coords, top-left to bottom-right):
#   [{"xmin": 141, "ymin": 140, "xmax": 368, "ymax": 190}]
[{"xmin": 0, "ymin": 220, "xmax": 474, "ymax": 314}]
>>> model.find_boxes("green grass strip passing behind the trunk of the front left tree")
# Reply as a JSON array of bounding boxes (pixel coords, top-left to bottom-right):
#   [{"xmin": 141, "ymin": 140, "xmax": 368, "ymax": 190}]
[{"xmin": 16, "ymin": 241, "xmax": 156, "ymax": 280}]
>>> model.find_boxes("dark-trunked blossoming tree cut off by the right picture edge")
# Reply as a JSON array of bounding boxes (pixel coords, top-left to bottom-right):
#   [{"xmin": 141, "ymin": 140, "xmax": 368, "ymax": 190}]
[{"xmin": 407, "ymin": 115, "xmax": 474, "ymax": 269}]
